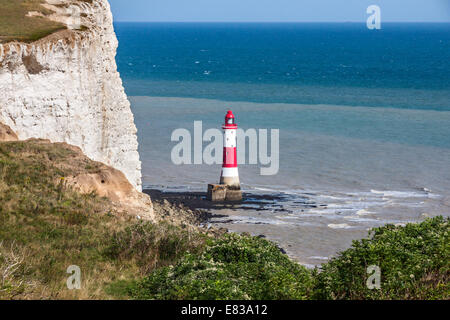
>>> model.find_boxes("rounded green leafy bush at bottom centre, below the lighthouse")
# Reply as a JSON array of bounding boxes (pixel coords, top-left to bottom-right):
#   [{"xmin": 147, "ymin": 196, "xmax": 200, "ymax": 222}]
[{"xmin": 128, "ymin": 234, "xmax": 312, "ymax": 300}]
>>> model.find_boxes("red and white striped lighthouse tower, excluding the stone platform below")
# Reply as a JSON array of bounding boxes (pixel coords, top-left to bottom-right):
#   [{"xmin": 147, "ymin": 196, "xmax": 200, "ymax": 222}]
[{"xmin": 220, "ymin": 110, "xmax": 241, "ymax": 189}]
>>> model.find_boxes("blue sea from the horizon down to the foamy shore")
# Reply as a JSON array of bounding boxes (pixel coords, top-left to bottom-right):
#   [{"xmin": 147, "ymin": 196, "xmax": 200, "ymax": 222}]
[{"xmin": 115, "ymin": 23, "xmax": 450, "ymax": 265}]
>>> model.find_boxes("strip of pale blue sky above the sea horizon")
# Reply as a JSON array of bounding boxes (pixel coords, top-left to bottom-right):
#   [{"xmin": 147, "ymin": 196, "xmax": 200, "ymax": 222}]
[{"xmin": 109, "ymin": 0, "xmax": 450, "ymax": 22}]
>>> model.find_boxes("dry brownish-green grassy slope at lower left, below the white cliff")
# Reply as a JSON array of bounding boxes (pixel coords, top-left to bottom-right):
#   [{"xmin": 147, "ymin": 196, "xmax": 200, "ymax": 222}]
[{"xmin": 0, "ymin": 141, "xmax": 204, "ymax": 300}]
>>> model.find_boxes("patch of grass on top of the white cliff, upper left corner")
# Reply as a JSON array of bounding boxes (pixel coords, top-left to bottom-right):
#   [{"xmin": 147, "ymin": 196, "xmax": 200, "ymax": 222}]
[{"xmin": 0, "ymin": 0, "xmax": 66, "ymax": 43}]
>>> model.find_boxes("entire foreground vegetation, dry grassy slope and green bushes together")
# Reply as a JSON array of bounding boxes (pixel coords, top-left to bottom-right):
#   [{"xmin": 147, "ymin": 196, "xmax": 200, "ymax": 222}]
[{"xmin": 0, "ymin": 140, "xmax": 450, "ymax": 299}]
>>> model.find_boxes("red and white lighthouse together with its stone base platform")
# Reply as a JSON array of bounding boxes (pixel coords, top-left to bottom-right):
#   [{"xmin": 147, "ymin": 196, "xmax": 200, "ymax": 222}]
[{"xmin": 207, "ymin": 110, "xmax": 242, "ymax": 201}]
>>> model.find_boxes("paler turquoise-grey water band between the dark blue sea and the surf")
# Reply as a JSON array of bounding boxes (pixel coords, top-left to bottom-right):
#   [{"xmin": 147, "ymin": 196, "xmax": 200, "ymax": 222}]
[{"xmin": 131, "ymin": 97, "xmax": 450, "ymax": 193}]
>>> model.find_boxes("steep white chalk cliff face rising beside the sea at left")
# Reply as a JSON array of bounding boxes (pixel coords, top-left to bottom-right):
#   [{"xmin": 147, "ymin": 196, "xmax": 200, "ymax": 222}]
[{"xmin": 0, "ymin": 0, "xmax": 141, "ymax": 191}]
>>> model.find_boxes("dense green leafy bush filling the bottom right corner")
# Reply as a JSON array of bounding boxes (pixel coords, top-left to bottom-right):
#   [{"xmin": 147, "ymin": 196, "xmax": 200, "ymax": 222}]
[{"xmin": 315, "ymin": 216, "xmax": 450, "ymax": 299}]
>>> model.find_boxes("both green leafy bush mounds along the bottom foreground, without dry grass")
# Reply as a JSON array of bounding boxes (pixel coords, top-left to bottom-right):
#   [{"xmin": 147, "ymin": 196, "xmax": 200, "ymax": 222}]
[{"xmin": 117, "ymin": 217, "xmax": 450, "ymax": 299}]
